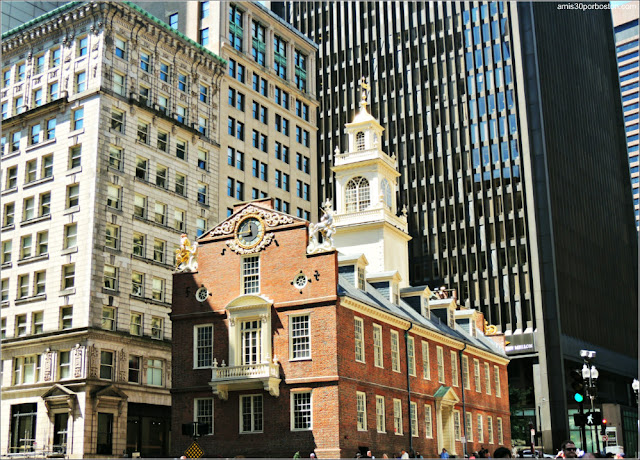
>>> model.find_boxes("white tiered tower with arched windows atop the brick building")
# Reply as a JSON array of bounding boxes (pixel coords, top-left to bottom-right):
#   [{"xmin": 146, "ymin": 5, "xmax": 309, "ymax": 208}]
[{"xmin": 331, "ymin": 79, "xmax": 411, "ymax": 288}]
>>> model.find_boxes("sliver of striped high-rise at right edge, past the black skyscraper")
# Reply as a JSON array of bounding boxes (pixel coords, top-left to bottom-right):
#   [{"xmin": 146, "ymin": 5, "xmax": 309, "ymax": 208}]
[{"xmin": 611, "ymin": 2, "xmax": 640, "ymax": 228}]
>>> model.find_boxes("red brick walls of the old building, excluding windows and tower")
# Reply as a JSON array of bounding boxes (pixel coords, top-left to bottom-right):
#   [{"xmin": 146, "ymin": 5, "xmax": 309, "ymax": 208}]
[{"xmin": 171, "ymin": 201, "xmax": 510, "ymax": 458}]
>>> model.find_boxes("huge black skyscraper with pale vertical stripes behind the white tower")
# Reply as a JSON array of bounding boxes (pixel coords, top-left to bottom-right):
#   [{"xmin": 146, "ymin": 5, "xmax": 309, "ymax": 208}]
[{"xmin": 280, "ymin": 1, "xmax": 638, "ymax": 451}]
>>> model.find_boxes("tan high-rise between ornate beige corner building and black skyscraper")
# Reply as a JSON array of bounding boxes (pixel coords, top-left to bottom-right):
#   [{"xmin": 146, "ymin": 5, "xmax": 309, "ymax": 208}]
[{"xmin": 130, "ymin": 1, "xmax": 318, "ymax": 221}]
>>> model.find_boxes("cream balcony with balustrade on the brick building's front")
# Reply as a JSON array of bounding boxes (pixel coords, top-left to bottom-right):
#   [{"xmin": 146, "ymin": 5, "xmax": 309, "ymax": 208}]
[{"xmin": 209, "ymin": 358, "xmax": 281, "ymax": 401}]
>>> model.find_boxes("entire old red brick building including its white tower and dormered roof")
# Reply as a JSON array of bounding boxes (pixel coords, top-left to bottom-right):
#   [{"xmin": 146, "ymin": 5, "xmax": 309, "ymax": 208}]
[{"xmin": 171, "ymin": 86, "xmax": 510, "ymax": 458}]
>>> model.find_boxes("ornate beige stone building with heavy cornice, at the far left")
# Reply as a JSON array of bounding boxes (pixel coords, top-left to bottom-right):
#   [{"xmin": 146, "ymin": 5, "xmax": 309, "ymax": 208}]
[{"xmin": 0, "ymin": 2, "xmax": 225, "ymax": 458}]
